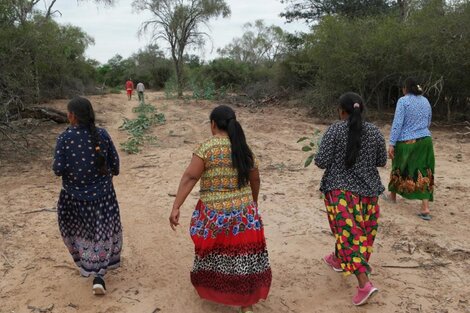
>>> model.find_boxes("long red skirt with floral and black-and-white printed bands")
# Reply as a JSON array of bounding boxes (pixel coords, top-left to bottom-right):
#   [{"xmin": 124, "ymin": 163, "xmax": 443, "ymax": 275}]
[{"xmin": 190, "ymin": 201, "xmax": 271, "ymax": 306}]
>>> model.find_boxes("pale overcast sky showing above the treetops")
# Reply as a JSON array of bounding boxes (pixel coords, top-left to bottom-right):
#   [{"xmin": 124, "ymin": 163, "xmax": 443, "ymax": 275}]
[{"xmin": 54, "ymin": 0, "xmax": 308, "ymax": 63}]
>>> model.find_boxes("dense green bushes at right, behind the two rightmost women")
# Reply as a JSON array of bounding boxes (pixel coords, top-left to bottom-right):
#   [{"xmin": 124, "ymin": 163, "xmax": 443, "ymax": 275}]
[{"xmin": 286, "ymin": 0, "xmax": 470, "ymax": 119}]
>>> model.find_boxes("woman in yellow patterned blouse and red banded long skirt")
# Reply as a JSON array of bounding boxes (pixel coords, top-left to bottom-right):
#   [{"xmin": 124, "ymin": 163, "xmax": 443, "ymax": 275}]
[{"xmin": 170, "ymin": 105, "xmax": 271, "ymax": 313}]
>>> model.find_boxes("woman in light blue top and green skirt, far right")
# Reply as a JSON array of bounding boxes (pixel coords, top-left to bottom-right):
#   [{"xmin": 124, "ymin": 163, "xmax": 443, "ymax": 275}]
[{"xmin": 385, "ymin": 78, "xmax": 435, "ymax": 221}]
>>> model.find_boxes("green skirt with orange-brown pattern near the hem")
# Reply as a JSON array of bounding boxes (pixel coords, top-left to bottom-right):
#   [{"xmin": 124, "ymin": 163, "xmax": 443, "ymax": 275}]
[{"xmin": 388, "ymin": 137, "xmax": 435, "ymax": 201}]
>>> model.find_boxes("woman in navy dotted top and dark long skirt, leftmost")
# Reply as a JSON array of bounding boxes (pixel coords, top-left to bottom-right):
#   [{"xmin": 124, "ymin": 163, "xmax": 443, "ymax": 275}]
[{"xmin": 53, "ymin": 97, "xmax": 122, "ymax": 295}]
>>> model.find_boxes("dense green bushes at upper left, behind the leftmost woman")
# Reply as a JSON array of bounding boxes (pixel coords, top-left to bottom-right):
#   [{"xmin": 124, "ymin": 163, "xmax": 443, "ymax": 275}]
[{"xmin": 0, "ymin": 0, "xmax": 96, "ymax": 120}]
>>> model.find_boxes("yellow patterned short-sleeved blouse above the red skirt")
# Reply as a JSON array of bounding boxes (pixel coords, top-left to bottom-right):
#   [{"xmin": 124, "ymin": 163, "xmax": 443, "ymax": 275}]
[{"xmin": 194, "ymin": 136, "xmax": 258, "ymax": 211}]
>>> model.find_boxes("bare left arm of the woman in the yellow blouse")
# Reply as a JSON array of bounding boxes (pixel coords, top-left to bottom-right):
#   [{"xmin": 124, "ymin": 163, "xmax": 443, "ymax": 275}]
[{"xmin": 170, "ymin": 154, "xmax": 204, "ymax": 230}]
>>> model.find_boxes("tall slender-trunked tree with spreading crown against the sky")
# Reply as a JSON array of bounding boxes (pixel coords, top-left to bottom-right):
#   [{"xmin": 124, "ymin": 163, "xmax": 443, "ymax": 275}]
[{"xmin": 134, "ymin": 0, "xmax": 230, "ymax": 97}]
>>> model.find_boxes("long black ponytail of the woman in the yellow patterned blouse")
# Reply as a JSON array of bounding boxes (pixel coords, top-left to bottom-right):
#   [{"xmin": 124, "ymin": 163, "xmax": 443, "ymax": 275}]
[{"xmin": 210, "ymin": 105, "xmax": 254, "ymax": 188}]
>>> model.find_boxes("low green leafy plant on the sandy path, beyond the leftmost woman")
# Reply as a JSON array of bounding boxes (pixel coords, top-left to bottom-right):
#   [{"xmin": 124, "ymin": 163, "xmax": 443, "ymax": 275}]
[{"xmin": 119, "ymin": 102, "xmax": 166, "ymax": 154}]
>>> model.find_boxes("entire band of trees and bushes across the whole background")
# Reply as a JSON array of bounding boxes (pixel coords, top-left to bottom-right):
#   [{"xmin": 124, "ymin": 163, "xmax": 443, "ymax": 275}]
[{"xmin": 0, "ymin": 0, "xmax": 470, "ymax": 121}]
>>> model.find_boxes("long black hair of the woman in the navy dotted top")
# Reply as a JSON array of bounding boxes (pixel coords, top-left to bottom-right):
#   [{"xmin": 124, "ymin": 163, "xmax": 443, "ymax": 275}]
[{"xmin": 67, "ymin": 97, "xmax": 109, "ymax": 175}]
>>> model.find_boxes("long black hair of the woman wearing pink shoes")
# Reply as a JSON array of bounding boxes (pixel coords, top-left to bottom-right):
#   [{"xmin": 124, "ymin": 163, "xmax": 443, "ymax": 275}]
[{"xmin": 339, "ymin": 92, "xmax": 364, "ymax": 168}]
